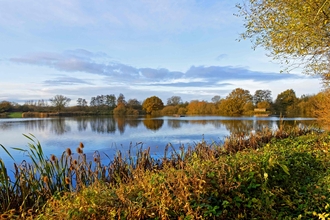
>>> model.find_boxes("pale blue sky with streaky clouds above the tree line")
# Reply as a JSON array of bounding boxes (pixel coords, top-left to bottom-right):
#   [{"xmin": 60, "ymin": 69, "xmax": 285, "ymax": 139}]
[{"xmin": 0, "ymin": 0, "xmax": 321, "ymax": 105}]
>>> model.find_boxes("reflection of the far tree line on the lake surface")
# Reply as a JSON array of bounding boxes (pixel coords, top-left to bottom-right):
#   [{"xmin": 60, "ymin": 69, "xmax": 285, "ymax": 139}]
[{"xmin": 0, "ymin": 117, "xmax": 315, "ymax": 135}]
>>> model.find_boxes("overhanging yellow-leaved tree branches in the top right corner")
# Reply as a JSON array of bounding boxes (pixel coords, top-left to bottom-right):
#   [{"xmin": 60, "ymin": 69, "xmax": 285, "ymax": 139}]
[{"xmin": 237, "ymin": 0, "xmax": 330, "ymax": 80}]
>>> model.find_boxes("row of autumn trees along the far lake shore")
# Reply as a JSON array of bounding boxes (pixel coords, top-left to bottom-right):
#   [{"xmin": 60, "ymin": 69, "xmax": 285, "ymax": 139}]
[{"xmin": 0, "ymin": 88, "xmax": 325, "ymax": 117}]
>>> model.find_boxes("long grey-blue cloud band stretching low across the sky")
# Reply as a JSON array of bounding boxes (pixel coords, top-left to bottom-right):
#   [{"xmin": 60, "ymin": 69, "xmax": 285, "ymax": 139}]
[{"xmin": 10, "ymin": 49, "xmax": 303, "ymax": 87}]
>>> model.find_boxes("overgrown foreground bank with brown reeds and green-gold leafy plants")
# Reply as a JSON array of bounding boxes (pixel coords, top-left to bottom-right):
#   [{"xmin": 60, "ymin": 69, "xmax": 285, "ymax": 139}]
[{"xmin": 0, "ymin": 128, "xmax": 330, "ymax": 219}]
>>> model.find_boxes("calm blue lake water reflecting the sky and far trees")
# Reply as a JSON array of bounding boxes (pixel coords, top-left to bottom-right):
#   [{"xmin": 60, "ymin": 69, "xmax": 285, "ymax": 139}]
[{"xmin": 0, "ymin": 116, "xmax": 315, "ymax": 165}]
